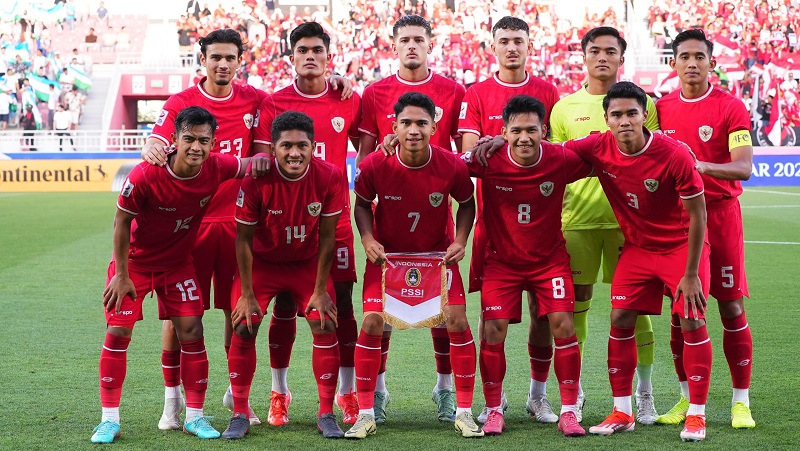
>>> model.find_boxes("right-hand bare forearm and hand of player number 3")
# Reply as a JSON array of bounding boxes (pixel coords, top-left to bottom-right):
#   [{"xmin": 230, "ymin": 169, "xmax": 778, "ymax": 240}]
[{"xmin": 675, "ymin": 192, "xmax": 706, "ymax": 320}]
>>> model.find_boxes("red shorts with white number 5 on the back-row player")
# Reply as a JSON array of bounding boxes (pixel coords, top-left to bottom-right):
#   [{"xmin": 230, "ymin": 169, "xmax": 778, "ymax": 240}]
[{"xmin": 708, "ymin": 199, "xmax": 750, "ymax": 302}]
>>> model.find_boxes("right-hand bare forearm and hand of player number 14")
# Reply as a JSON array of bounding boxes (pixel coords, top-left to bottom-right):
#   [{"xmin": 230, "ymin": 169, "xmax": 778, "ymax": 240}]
[{"xmin": 306, "ymin": 214, "xmax": 339, "ymax": 330}]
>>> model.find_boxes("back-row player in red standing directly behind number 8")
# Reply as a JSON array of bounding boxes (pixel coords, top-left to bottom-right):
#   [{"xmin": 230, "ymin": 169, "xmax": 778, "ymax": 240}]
[{"xmin": 458, "ymin": 16, "xmax": 558, "ymax": 423}]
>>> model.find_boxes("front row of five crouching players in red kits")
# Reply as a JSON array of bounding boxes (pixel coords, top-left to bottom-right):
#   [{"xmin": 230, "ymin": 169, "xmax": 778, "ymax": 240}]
[{"xmin": 92, "ymin": 83, "xmax": 711, "ymax": 443}]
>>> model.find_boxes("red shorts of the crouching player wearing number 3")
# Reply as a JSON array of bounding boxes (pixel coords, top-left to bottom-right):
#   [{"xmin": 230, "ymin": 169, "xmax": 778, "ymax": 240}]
[{"xmin": 611, "ymin": 244, "xmax": 710, "ymax": 318}]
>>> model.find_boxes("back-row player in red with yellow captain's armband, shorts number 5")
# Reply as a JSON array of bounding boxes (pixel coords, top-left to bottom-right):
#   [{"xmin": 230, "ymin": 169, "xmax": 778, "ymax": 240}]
[{"xmin": 656, "ymin": 30, "xmax": 756, "ymax": 429}]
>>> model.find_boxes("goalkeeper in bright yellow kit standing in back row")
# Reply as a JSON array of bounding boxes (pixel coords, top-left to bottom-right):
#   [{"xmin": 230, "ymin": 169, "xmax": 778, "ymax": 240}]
[{"xmin": 550, "ymin": 27, "xmax": 658, "ymax": 424}]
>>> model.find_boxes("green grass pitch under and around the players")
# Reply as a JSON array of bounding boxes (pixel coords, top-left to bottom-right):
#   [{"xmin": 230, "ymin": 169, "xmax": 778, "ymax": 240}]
[{"xmin": 0, "ymin": 188, "xmax": 800, "ymax": 450}]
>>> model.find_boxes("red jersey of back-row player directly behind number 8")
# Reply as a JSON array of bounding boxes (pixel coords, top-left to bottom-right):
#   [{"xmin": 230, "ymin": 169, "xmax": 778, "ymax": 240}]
[{"xmin": 458, "ymin": 73, "xmax": 559, "ymax": 136}]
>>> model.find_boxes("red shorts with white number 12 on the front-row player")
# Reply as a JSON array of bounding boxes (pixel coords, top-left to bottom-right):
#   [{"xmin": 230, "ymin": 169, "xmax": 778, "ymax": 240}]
[{"xmin": 106, "ymin": 261, "xmax": 204, "ymax": 327}]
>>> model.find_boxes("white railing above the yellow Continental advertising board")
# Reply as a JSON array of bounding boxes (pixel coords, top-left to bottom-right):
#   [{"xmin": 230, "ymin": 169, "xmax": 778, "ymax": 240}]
[{"xmin": 0, "ymin": 129, "xmax": 150, "ymax": 153}]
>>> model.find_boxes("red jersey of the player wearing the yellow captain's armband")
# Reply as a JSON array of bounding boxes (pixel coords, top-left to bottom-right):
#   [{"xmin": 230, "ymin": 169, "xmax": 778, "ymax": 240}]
[{"xmin": 656, "ymin": 86, "xmax": 752, "ymax": 204}]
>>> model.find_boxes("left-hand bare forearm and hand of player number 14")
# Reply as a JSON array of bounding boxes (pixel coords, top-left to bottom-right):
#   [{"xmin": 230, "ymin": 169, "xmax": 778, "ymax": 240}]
[{"xmin": 231, "ymin": 222, "xmax": 264, "ymax": 334}]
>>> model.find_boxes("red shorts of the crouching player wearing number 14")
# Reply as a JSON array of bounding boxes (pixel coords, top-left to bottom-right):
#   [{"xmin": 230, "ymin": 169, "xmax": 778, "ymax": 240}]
[{"xmin": 230, "ymin": 257, "xmax": 336, "ymax": 323}]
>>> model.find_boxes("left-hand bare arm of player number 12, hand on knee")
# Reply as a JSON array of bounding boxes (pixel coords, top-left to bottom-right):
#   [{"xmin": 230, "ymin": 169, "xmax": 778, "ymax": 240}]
[{"xmin": 103, "ymin": 208, "xmax": 136, "ymax": 314}]
